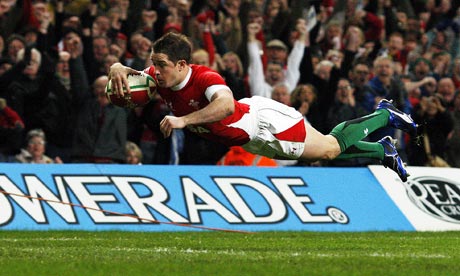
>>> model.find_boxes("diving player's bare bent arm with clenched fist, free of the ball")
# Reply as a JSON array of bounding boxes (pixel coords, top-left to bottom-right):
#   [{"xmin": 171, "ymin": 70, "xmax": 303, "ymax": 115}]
[{"xmin": 160, "ymin": 89, "xmax": 235, "ymax": 137}]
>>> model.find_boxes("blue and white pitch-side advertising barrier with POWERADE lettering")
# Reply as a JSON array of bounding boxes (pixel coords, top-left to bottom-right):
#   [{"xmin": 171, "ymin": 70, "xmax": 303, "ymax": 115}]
[{"xmin": 0, "ymin": 164, "xmax": 460, "ymax": 233}]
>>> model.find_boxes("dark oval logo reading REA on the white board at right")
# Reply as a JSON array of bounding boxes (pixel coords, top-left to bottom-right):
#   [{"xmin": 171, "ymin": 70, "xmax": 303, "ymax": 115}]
[{"xmin": 405, "ymin": 176, "xmax": 460, "ymax": 223}]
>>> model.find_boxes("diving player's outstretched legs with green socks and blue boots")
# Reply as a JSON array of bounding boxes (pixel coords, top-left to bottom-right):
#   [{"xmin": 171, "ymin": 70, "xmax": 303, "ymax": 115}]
[{"xmin": 301, "ymin": 100, "xmax": 417, "ymax": 181}]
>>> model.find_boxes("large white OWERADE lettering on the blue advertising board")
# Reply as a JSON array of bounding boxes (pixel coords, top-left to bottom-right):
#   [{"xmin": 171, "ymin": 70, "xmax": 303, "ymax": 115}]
[{"xmin": 0, "ymin": 174, "xmax": 349, "ymax": 226}]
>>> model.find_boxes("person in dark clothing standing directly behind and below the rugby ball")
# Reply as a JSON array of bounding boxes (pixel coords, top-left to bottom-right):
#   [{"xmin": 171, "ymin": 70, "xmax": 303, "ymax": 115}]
[{"xmin": 72, "ymin": 75, "xmax": 127, "ymax": 163}]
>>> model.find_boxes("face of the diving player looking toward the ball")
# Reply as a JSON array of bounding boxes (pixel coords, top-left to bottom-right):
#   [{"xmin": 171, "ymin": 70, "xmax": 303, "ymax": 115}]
[{"xmin": 151, "ymin": 53, "xmax": 183, "ymax": 88}]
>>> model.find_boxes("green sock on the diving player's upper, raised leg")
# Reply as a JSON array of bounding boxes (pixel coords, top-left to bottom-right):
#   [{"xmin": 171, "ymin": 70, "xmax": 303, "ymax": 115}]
[{"xmin": 330, "ymin": 109, "xmax": 390, "ymax": 152}]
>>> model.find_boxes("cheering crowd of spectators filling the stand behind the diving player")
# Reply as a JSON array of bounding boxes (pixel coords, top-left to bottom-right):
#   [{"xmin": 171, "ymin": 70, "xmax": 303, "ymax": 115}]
[{"xmin": 0, "ymin": 0, "xmax": 460, "ymax": 167}]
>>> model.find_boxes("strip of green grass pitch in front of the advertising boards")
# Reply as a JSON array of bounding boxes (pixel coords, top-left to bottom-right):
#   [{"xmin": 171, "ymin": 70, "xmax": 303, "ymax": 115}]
[{"xmin": 0, "ymin": 231, "xmax": 460, "ymax": 276}]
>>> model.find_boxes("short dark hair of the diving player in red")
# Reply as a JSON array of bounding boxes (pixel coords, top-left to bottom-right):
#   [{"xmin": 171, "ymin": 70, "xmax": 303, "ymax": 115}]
[{"xmin": 152, "ymin": 32, "xmax": 192, "ymax": 63}]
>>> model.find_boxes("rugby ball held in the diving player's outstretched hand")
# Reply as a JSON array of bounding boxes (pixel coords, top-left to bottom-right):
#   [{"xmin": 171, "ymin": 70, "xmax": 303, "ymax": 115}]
[{"xmin": 105, "ymin": 72, "xmax": 157, "ymax": 108}]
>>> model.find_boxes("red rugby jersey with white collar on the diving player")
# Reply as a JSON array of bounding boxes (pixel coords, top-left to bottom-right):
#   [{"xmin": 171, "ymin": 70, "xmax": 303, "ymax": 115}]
[{"xmin": 144, "ymin": 64, "xmax": 249, "ymax": 146}]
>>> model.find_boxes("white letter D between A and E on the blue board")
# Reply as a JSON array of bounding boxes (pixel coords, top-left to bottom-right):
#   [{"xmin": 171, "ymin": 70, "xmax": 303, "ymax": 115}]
[{"xmin": 214, "ymin": 177, "xmax": 287, "ymax": 223}]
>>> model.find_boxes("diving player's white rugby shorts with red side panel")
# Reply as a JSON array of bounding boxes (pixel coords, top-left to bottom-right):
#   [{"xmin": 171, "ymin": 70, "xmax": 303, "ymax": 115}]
[{"xmin": 230, "ymin": 96, "xmax": 306, "ymax": 159}]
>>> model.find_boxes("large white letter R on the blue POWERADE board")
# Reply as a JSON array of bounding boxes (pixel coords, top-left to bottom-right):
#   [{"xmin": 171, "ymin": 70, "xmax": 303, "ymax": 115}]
[{"xmin": 112, "ymin": 177, "xmax": 188, "ymax": 223}]
